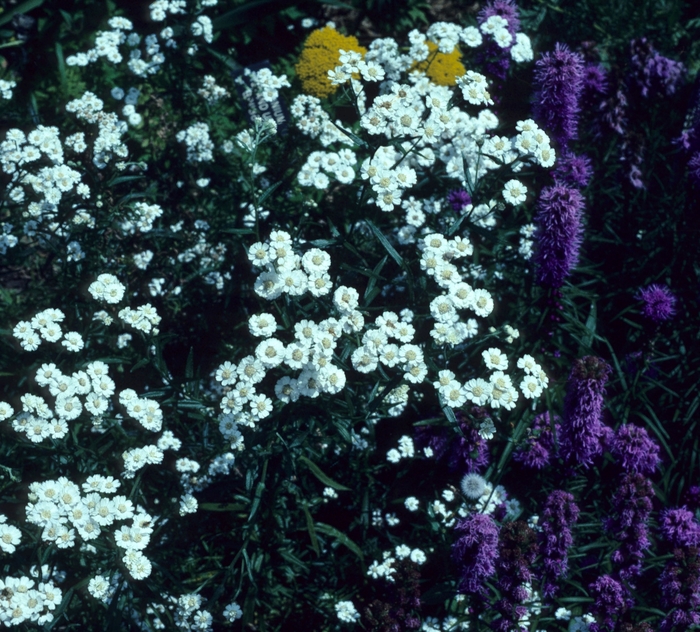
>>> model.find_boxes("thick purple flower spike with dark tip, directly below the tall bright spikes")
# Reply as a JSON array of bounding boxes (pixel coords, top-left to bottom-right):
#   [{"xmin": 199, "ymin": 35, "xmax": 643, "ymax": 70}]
[{"xmin": 559, "ymin": 356, "xmax": 611, "ymax": 467}]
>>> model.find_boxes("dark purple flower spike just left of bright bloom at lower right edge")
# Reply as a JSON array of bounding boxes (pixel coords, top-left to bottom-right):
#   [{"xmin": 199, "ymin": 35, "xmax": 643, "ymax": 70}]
[{"xmin": 603, "ymin": 473, "xmax": 654, "ymax": 580}]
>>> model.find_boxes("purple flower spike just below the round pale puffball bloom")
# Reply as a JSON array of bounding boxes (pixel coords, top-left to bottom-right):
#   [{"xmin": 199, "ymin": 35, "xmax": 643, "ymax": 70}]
[{"xmin": 452, "ymin": 514, "xmax": 498, "ymax": 594}]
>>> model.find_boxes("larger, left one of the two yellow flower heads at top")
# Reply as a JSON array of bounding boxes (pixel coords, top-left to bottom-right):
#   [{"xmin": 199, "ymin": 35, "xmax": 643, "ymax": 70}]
[{"xmin": 296, "ymin": 26, "xmax": 366, "ymax": 98}]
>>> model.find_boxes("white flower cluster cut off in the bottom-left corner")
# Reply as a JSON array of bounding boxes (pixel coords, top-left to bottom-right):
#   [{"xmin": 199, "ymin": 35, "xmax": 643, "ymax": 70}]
[{"xmin": 0, "ymin": 577, "xmax": 63, "ymax": 628}]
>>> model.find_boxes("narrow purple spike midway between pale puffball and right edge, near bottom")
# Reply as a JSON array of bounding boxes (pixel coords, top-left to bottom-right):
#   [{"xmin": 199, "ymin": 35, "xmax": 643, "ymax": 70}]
[{"xmin": 541, "ymin": 490, "xmax": 579, "ymax": 597}]
